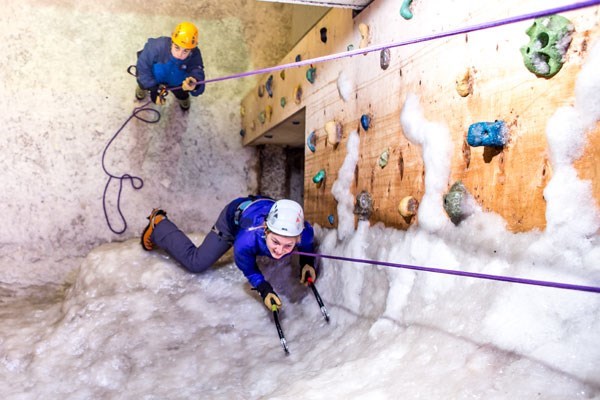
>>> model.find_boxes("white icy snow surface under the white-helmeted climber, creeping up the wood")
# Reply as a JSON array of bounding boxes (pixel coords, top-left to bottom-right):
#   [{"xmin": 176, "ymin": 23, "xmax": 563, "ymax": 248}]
[{"xmin": 0, "ymin": 5, "xmax": 600, "ymax": 400}]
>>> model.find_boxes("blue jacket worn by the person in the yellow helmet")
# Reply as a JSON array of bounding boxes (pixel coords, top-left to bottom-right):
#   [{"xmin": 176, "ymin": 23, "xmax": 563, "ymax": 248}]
[{"xmin": 136, "ymin": 36, "xmax": 204, "ymax": 96}]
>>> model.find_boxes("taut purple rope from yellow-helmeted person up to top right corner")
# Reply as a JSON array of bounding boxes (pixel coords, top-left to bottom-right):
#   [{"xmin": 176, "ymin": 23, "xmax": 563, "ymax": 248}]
[{"xmin": 189, "ymin": 0, "xmax": 600, "ymax": 90}]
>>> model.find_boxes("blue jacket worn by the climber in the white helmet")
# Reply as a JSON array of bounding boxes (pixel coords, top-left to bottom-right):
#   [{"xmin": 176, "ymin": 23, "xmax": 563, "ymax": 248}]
[{"xmin": 227, "ymin": 198, "xmax": 315, "ymax": 287}]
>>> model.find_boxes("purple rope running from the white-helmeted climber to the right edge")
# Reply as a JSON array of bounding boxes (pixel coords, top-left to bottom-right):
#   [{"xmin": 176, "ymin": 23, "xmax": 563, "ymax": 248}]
[{"xmin": 292, "ymin": 251, "xmax": 600, "ymax": 293}]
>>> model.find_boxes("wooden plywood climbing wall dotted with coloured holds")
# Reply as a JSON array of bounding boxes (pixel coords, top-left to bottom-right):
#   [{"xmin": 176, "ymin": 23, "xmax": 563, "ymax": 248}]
[{"xmin": 242, "ymin": 0, "xmax": 600, "ymax": 231}]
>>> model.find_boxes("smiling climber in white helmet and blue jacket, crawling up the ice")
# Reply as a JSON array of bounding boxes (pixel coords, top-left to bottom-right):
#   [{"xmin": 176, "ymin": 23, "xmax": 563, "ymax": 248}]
[{"xmin": 141, "ymin": 196, "xmax": 317, "ymax": 310}]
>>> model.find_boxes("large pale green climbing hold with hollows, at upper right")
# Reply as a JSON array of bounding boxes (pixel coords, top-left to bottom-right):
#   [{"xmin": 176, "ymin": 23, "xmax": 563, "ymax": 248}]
[{"xmin": 521, "ymin": 15, "xmax": 575, "ymax": 78}]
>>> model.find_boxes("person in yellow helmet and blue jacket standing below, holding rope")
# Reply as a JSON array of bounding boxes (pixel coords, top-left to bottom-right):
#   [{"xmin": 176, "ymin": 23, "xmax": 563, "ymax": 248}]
[{"xmin": 135, "ymin": 22, "xmax": 204, "ymax": 111}]
